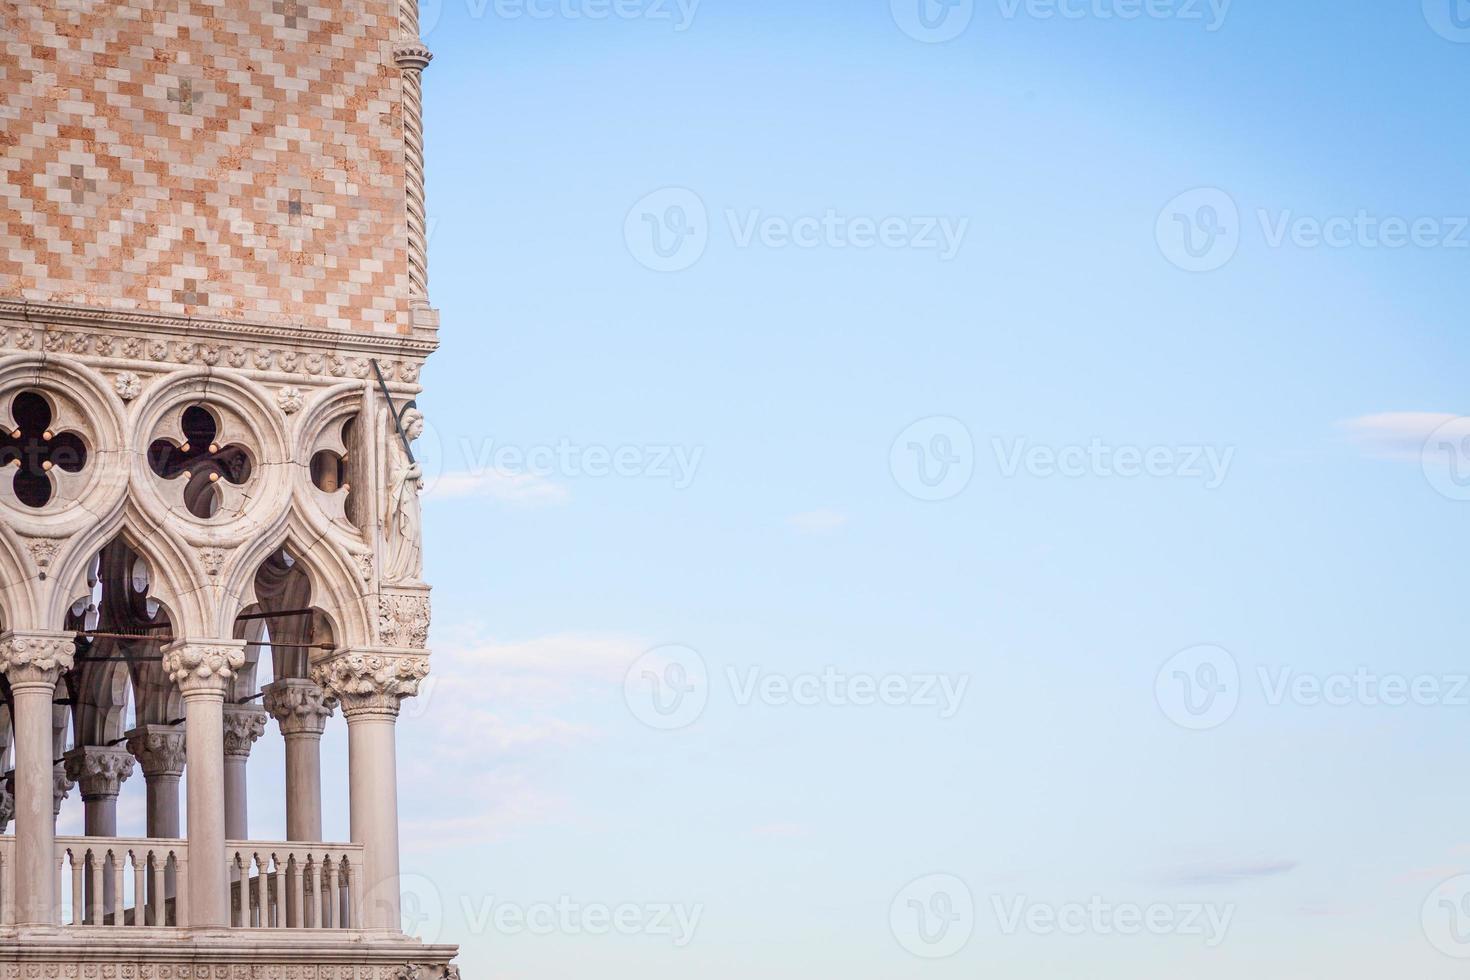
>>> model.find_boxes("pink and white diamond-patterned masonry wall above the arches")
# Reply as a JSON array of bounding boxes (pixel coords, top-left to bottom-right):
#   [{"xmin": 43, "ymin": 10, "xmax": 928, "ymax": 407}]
[{"xmin": 0, "ymin": 0, "xmax": 412, "ymax": 334}]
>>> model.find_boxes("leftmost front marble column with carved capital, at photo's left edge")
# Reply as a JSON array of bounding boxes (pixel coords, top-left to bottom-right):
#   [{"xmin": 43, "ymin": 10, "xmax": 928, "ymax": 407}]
[{"xmin": 0, "ymin": 632, "xmax": 76, "ymax": 926}]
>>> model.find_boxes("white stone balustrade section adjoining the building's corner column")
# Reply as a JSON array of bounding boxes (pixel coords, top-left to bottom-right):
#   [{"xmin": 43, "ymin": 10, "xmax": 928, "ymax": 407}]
[{"xmin": 226, "ymin": 840, "xmax": 365, "ymax": 929}]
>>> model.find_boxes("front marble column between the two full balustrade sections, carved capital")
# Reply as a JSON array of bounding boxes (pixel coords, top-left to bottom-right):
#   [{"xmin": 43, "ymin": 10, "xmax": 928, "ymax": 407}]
[{"xmin": 163, "ymin": 639, "xmax": 245, "ymax": 929}]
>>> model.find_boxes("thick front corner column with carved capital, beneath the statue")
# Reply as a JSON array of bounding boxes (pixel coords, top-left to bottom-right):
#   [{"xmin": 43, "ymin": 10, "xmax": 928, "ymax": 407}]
[{"xmin": 312, "ymin": 651, "xmax": 429, "ymax": 933}]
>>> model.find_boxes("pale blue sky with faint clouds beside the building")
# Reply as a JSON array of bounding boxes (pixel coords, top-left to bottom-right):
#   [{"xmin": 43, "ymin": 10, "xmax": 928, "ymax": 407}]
[{"xmin": 74, "ymin": 0, "xmax": 1470, "ymax": 980}]
